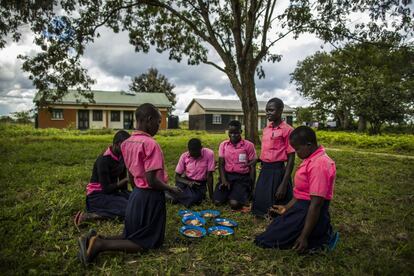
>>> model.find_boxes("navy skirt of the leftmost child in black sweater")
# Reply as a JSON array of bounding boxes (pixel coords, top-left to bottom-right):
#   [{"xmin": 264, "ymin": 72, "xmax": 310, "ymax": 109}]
[{"xmin": 86, "ymin": 191, "xmax": 131, "ymax": 219}]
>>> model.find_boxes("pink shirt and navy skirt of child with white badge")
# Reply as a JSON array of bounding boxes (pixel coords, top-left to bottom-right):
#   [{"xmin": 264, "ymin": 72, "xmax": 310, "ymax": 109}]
[{"xmin": 213, "ymin": 139, "xmax": 257, "ymax": 204}]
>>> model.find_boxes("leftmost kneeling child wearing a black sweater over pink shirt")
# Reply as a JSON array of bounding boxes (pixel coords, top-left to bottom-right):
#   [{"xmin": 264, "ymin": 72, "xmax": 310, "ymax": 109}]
[{"xmin": 74, "ymin": 130, "xmax": 130, "ymax": 229}]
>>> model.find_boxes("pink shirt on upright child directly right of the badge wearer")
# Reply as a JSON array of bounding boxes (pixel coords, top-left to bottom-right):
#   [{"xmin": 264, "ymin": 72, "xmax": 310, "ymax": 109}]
[{"xmin": 260, "ymin": 121, "xmax": 295, "ymax": 163}]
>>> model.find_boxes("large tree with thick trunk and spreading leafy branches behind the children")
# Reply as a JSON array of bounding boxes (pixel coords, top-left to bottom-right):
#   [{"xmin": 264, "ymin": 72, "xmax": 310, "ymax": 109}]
[{"xmin": 0, "ymin": 0, "xmax": 413, "ymax": 142}]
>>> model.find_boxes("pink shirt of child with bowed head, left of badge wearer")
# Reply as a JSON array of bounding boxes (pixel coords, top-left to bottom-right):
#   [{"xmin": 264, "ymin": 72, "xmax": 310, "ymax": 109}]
[{"xmin": 175, "ymin": 148, "xmax": 215, "ymax": 181}]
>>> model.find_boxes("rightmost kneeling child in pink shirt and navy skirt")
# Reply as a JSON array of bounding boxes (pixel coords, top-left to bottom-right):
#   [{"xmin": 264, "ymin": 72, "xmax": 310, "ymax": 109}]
[{"xmin": 255, "ymin": 126, "xmax": 339, "ymax": 252}]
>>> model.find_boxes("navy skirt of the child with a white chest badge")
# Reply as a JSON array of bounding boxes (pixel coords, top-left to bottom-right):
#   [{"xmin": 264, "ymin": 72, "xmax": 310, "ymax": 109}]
[{"xmin": 213, "ymin": 172, "xmax": 251, "ymax": 204}]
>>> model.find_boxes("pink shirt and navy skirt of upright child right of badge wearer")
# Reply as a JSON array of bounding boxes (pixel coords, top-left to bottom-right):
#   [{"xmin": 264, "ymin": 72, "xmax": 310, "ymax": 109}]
[{"xmin": 252, "ymin": 121, "xmax": 295, "ymax": 216}]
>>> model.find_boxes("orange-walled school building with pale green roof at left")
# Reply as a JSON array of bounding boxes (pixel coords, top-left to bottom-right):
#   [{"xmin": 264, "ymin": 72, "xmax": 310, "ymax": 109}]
[{"xmin": 33, "ymin": 90, "xmax": 171, "ymax": 130}]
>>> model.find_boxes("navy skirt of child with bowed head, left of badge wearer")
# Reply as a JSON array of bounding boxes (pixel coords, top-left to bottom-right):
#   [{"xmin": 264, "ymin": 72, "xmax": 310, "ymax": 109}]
[{"xmin": 174, "ymin": 180, "xmax": 207, "ymax": 208}]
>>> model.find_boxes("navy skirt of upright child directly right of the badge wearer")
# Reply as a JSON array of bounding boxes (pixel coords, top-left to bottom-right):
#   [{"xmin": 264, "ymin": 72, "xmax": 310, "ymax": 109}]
[{"xmin": 252, "ymin": 162, "xmax": 293, "ymax": 217}]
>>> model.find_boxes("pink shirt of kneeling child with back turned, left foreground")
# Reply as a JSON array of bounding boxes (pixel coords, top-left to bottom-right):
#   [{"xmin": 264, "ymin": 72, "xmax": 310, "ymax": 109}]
[{"xmin": 121, "ymin": 131, "xmax": 168, "ymax": 189}]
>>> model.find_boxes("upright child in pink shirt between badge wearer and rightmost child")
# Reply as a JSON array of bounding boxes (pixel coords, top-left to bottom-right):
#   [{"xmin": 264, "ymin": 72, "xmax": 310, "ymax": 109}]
[{"xmin": 252, "ymin": 98, "xmax": 295, "ymax": 217}]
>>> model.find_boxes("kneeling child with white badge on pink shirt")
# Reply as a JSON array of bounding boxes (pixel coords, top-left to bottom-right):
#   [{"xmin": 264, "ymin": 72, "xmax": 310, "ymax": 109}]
[{"xmin": 213, "ymin": 121, "xmax": 257, "ymax": 210}]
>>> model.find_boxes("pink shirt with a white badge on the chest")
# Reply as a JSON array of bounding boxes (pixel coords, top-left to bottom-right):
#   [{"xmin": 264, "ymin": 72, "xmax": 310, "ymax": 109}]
[{"xmin": 219, "ymin": 139, "xmax": 257, "ymax": 174}]
